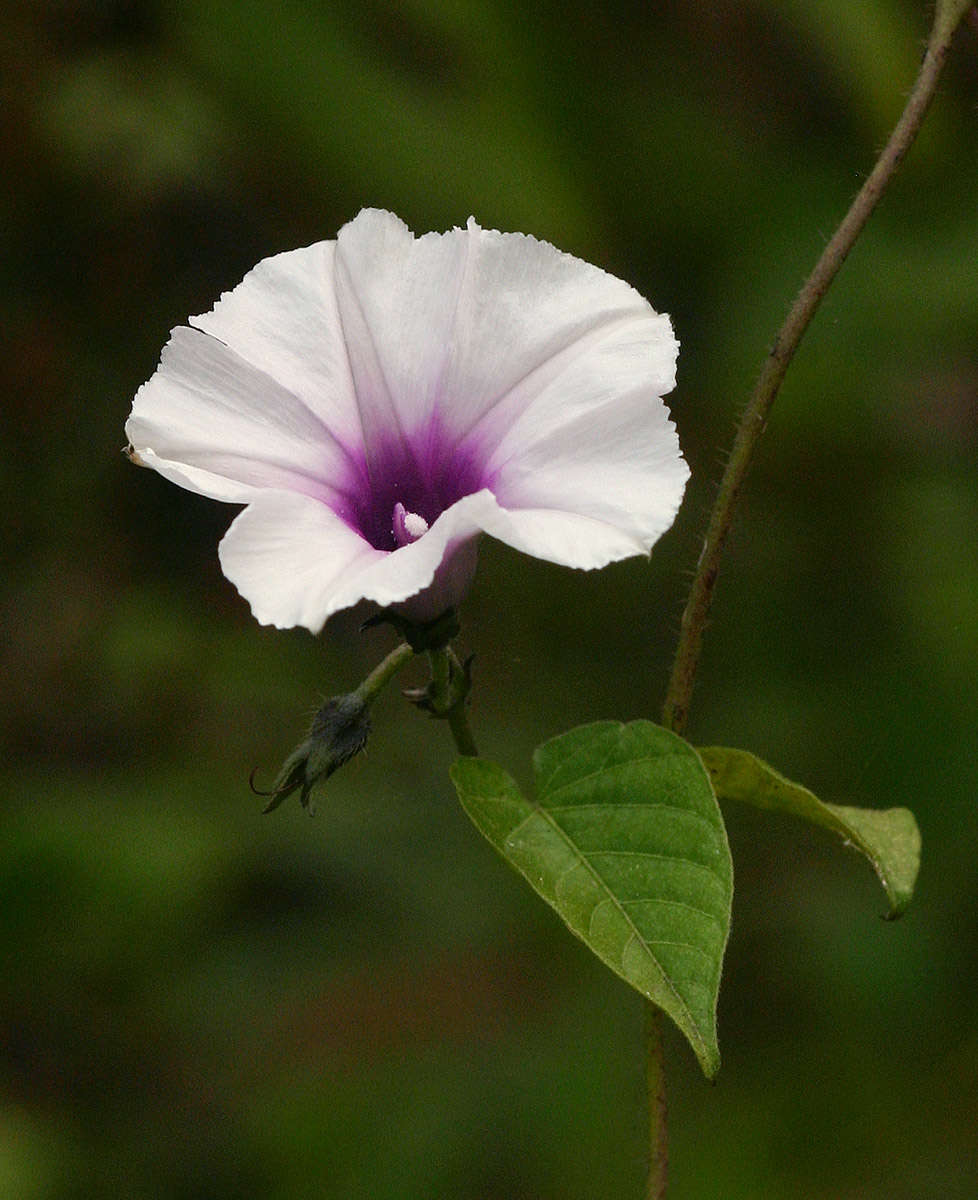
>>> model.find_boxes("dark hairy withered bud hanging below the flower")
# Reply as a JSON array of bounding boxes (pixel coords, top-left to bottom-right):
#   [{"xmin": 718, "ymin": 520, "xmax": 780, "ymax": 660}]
[{"xmin": 251, "ymin": 691, "xmax": 371, "ymax": 816}]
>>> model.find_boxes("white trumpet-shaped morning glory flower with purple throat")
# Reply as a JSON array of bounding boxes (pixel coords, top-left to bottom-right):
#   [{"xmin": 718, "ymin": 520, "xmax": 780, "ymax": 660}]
[{"xmin": 126, "ymin": 209, "xmax": 689, "ymax": 632}]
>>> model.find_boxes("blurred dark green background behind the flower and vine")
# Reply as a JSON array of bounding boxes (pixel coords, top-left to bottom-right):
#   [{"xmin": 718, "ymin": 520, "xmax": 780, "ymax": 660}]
[{"xmin": 0, "ymin": 0, "xmax": 978, "ymax": 1200}]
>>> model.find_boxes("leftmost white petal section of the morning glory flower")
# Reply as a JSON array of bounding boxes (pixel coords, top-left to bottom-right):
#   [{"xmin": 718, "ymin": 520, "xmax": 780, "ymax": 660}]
[{"xmin": 126, "ymin": 328, "xmax": 355, "ymax": 511}]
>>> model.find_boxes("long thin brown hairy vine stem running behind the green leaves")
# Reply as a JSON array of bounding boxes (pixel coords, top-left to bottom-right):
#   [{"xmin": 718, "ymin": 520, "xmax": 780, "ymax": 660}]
[{"xmin": 646, "ymin": 0, "xmax": 976, "ymax": 1200}]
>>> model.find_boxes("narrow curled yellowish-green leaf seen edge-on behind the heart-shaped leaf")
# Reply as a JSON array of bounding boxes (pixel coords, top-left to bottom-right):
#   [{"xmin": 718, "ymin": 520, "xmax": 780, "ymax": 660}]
[{"xmin": 700, "ymin": 746, "xmax": 920, "ymax": 919}]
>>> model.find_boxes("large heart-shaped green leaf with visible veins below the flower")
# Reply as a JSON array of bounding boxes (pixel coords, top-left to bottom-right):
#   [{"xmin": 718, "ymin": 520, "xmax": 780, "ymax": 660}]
[{"xmin": 451, "ymin": 721, "xmax": 733, "ymax": 1076}]
